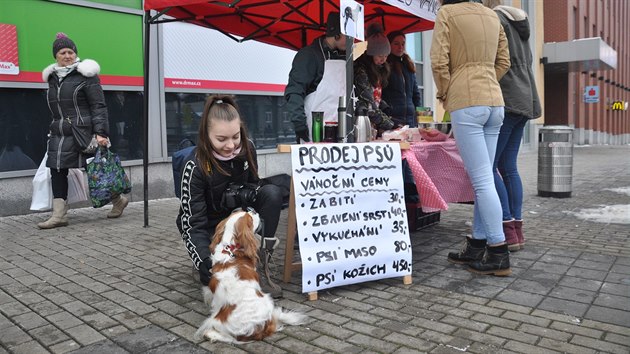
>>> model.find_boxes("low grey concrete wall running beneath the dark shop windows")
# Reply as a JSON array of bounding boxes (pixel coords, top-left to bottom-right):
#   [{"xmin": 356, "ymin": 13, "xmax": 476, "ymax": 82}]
[{"xmin": 0, "ymin": 152, "xmax": 291, "ymax": 216}]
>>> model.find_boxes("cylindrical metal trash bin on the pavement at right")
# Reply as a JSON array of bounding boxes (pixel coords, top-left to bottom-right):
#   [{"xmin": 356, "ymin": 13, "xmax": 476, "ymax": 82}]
[{"xmin": 538, "ymin": 125, "xmax": 573, "ymax": 198}]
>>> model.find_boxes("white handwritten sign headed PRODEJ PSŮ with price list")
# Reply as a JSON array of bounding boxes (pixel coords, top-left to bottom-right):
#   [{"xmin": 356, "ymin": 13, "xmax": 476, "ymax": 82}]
[{"xmin": 291, "ymin": 143, "xmax": 411, "ymax": 292}]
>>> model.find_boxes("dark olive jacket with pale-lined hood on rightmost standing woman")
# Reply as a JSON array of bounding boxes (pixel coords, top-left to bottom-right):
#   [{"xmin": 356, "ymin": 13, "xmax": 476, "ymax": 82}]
[{"xmin": 494, "ymin": 6, "xmax": 542, "ymax": 119}]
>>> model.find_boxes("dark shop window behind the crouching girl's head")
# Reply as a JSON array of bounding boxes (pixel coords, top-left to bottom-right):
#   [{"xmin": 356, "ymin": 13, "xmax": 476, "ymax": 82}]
[{"xmin": 165, "ymin": 92, "xmax": 295, "ymax": 156}]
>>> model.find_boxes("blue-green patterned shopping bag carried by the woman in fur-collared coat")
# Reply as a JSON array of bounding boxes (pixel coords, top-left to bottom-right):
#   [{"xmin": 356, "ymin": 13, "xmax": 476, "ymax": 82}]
[{"xmin": 86, "ymin": 149, "xmax": 131, "ymax": 208}]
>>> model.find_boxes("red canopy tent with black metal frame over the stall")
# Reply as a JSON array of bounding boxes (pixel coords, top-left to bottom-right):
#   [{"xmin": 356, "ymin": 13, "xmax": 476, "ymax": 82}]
[{"xmin": 143, "ymin": 0, "xmax": 437, "ymax": 227}]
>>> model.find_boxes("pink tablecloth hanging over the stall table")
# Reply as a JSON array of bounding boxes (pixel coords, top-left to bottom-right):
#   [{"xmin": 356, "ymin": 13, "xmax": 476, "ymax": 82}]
[{"xmin": 402, "ymin": 139, "xmax": 475, "ymax": 212}]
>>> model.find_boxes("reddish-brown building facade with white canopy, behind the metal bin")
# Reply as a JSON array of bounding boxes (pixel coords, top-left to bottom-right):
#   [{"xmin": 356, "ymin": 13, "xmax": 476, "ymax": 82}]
[{"xmin": 541, "ymin": 0, "xmax": 630, "ymax": 145}]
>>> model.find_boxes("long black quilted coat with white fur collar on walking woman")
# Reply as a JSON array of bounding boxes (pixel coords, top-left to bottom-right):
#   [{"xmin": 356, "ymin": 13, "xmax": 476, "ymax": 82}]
[{"xmin": 43, "ymin": 59, "xmax": 109, "ymax": 169}]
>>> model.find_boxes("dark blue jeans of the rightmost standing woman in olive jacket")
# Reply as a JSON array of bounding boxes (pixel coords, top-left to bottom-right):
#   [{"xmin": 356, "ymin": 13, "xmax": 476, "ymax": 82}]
[{"xmin": 492, "ymin": 113, "xmax": 528, "ymax": 221}]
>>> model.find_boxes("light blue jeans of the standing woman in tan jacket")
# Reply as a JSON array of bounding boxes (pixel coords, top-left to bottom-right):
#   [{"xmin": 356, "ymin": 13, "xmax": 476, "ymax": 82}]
[{"xmin": 451, "ymin": 106, "xmax": 505, "ymax": 245}]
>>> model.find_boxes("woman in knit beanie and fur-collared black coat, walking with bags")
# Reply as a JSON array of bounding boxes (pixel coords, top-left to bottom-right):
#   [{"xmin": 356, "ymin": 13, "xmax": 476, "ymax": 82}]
[{"xmin": 37, "ymin": 33, "xmax": 128, "ymax": 229}]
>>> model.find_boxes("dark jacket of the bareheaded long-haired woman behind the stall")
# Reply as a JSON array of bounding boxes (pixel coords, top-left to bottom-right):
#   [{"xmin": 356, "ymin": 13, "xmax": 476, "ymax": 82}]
[{"xmin": 383, "ymin": 54, "xmax": 420, "ymax": 128}]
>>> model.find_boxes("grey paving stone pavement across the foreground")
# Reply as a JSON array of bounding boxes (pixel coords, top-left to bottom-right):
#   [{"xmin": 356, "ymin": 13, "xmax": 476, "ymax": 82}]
[{"xmin": 0, "ymin": 146, "xmax": 630, "ymax": 354}]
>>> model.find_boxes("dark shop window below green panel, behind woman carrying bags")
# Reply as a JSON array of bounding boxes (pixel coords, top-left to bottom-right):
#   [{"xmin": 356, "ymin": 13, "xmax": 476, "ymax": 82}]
[{"xmin": 0, "ymin": 88, "xmax": 143, "ymax": 172}]
